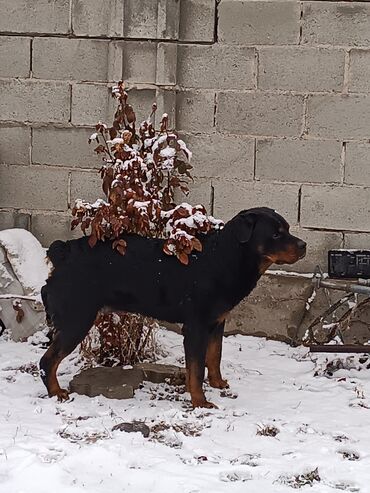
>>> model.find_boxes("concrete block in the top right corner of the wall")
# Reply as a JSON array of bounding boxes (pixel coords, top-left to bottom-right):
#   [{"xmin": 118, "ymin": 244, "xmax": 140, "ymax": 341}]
[{"xmin": 302, "ymin": 1, "xmax": 370, "ymax": 46}]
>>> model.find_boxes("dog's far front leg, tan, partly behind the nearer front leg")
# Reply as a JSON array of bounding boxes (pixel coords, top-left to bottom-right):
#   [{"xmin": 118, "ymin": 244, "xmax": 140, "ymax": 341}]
[{"xmin": 206, "ymin": 322, "xmax": 229, "ymax": 389}]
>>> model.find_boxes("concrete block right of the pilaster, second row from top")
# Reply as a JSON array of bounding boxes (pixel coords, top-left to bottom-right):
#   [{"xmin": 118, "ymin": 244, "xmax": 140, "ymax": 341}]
[{"xmin": 177, "ymin": 44, "xmax": 255, "ymax": 89}]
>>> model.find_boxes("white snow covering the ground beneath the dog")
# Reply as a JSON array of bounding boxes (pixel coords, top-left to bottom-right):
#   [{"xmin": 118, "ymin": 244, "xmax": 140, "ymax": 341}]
[{"xmin": 0, "ymin": 331, "xmax": 370, "ymax": 493}]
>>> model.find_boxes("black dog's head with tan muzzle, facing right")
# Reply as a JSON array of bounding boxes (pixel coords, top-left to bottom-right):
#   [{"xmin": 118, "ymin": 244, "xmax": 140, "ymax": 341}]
[{"xmin": 231, "ymin": 207, "xmax": 306, "ymax": 272}]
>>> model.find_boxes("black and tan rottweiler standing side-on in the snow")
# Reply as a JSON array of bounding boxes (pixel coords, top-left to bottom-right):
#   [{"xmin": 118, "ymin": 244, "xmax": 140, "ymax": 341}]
[{"xmin": 40, "ymin": 207, "xmax": 306, "ymax": 408}]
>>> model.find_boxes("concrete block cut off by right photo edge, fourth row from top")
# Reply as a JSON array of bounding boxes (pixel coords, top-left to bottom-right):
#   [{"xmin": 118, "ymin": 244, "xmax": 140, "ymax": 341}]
[{"xmin": 344, "ymin": 142, "xmax": 370, "ymax": 187}]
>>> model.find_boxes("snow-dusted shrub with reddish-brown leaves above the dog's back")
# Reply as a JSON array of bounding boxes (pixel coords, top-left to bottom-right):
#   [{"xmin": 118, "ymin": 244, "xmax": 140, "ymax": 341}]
[{"xmin": 72, "ymin": 82, "xmax": 222, "ymax": 264}]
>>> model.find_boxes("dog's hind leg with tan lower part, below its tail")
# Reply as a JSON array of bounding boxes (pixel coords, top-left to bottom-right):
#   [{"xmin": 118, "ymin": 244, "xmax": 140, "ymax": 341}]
[{"xmin": 40, "ymin": 307, "xmax": 96, "ymax": 401}]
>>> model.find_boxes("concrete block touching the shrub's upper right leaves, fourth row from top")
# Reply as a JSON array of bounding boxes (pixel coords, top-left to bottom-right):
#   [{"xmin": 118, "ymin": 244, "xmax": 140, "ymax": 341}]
[{"xmin": 181, "ymin": 134, "xmax": 254, "ymax": 180}]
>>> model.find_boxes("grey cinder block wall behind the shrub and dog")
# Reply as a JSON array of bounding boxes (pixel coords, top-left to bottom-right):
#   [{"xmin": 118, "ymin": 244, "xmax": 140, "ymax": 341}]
[{"xmin": 0, "ymin": 0, "xmax": 370, "ymax": 271}]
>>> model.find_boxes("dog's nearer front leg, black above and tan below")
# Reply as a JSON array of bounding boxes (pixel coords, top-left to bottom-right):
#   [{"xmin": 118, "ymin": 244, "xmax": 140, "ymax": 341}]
[{"xmin": 183, "ymin": 323, "xmax": 217, "ymax": 408}]
